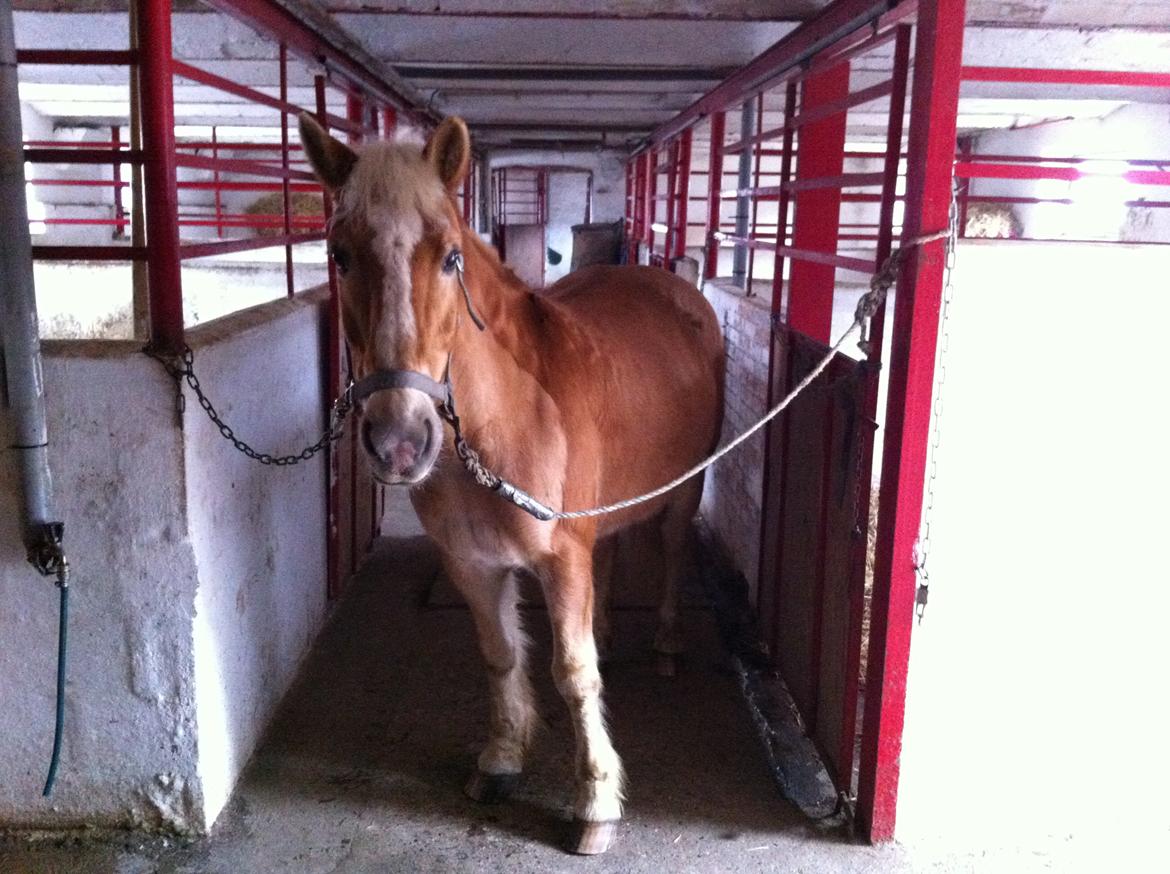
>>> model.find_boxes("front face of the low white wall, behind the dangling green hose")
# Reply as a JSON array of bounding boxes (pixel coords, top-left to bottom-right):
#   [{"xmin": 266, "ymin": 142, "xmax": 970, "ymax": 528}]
[{"xmin": 0, "ymin": 344, "xmax": 204, "ymax": 830}]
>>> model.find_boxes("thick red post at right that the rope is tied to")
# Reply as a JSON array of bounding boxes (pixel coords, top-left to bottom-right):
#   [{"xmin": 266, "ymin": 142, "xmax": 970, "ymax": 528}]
[{"xmin": 858, "ymin": 0, "xmax": 965, "ymax": 841}]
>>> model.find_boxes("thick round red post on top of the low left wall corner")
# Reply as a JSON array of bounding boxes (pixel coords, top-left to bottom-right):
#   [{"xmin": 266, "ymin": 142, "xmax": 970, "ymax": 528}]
[{"xmin": 138, "ymin": 0, "xmax": 183, "ymax": 351}]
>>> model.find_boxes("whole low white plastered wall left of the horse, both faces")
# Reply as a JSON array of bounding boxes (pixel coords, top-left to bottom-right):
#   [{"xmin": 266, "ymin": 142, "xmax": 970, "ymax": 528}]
[{"xmin": 0, "ymin": 290, "xmax": 325, "ymax": 831}]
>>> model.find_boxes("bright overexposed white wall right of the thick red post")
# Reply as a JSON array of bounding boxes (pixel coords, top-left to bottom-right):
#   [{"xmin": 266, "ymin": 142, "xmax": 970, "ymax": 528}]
[{"xmin": 894, "ymin": 242, "xmax": 1170, "ymax": 872}]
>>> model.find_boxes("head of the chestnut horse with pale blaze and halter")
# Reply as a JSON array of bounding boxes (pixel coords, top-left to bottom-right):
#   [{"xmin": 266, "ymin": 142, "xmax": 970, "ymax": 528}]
[{"xmin": 301, "ymin": 115, "xmax": 472, "ymax": 483}]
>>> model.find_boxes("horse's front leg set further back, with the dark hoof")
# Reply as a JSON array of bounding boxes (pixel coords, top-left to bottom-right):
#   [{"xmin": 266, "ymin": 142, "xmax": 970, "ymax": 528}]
[{"xmin": 446, "ymin": 559, "xmax": 537, "ymax": 804}]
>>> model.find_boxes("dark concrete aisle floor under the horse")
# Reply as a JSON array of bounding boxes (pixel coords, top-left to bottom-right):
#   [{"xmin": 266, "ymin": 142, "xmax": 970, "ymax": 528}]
[{"xmin": 0, "ymin": 538, "xmax": 992, "ymax": 874}]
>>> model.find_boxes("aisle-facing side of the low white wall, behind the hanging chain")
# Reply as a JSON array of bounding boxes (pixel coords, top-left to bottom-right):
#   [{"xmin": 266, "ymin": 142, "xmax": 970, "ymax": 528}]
[{"xmin": 185, "ymin": 301, "xmax": 326, "ymax": 823}]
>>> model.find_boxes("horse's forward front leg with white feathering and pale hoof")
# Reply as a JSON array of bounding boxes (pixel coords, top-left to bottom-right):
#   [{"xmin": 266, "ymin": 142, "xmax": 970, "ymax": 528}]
[{"xmin": 539, "ymin": 543, "xmax": 622, "ymax": 854}]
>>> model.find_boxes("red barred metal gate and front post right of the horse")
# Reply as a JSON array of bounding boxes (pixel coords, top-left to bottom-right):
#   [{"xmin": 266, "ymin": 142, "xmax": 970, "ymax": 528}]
[{"xmin": 626, "ymin": 0, "xmax": 964, "ymax": 840}]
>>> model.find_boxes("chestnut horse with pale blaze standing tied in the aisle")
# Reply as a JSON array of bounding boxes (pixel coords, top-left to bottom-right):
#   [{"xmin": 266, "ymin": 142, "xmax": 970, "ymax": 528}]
[{"xmin": 300, "ymin": 115, "xmax": 723, "ymax": 854}]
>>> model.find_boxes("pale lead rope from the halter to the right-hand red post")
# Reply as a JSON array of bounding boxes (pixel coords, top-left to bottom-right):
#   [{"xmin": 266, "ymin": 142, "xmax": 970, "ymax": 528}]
[{"xmin": 442, "ymin": 228, "xmax": 950, "ymax": 522}]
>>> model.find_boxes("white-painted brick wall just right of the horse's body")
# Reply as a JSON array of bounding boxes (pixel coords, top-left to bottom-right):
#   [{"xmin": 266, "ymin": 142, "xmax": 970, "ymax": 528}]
[{"xmin": 701, "ymin": 280, "xmax": 771, "ymax": 599}]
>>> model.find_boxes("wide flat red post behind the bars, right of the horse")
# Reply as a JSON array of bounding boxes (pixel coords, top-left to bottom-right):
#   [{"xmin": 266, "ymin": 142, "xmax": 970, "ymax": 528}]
[{"xmin": 787, "ymin": 63, "xmax": 849, "ymax": 343}]
